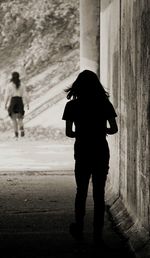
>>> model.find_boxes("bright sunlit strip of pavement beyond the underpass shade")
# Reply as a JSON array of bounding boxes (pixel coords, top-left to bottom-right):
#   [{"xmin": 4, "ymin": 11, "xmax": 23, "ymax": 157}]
[{"xmin": 0, "ymin": 138, "xmax": 74, "ymax": 173}]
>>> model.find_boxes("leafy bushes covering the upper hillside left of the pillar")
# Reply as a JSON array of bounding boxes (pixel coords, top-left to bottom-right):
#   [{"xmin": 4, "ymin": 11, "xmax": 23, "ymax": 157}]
[{"xmin": 0, "ymin": 0, "xmax": 79, "ymax": 77}]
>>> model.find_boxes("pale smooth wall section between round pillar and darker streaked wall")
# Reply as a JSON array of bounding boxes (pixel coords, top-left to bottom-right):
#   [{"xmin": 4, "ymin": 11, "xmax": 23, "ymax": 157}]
[{"xmin": 100, "ymin": 0, "xmax": 120, "ymax": 202}]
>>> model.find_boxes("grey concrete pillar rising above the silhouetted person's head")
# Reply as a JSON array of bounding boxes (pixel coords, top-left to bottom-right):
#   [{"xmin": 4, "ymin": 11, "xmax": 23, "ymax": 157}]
[{"xmin": 80, "ymin": 0, "xmax": 100, "ymax": 76}]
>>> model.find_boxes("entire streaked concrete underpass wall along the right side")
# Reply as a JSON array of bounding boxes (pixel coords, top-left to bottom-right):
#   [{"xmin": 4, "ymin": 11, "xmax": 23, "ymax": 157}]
[{"xmin": 100, "ymin": 0, "xmax": 150, "ymax": 254}]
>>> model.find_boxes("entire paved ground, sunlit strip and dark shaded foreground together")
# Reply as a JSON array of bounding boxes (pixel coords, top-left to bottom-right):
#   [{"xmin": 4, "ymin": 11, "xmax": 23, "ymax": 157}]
[{"xmin": 0, "ymin": 142, "xmax": 134, "ymax": 258}]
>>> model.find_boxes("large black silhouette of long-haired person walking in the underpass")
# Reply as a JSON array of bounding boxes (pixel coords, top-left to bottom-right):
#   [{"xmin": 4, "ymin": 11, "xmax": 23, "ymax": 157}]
[{"xmin": 62, "ymin": 70, "xmax": 118, "ymax": 245}]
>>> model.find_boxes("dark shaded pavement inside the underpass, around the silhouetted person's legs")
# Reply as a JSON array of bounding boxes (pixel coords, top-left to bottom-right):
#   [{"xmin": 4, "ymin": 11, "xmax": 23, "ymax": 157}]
[{"xmin": 0, "ymin": 171, "xmax": 137, "ymax": 258}]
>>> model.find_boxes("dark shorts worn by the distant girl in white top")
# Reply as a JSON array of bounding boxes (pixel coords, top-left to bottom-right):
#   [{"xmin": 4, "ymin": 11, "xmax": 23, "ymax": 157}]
[{"xmin": 8, "ymin": 96, "xmax": 25, "ymax": 118}]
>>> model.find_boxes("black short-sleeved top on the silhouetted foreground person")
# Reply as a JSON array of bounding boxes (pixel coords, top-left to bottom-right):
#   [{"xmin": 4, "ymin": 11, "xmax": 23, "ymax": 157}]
[{"xmin": 65, "ymin": 98, "xmax": 116, "ymax": 142}]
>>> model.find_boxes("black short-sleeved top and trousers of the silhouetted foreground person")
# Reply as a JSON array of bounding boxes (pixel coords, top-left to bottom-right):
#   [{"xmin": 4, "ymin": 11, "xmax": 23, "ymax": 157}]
[{"xmin": 62, "ymin": 96, "xmax": 117, "ymax": 234}]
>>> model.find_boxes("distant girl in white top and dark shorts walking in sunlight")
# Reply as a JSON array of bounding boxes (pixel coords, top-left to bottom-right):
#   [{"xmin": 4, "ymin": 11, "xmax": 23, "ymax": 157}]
[{"xmin": 5, "ymin": 72, "xmax": 29, "ymax": 138}]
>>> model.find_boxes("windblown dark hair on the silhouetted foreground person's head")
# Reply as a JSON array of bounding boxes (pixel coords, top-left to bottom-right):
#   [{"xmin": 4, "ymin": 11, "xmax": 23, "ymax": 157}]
[{"xmin": 65, "ymin": 70, "xmax": 109, "ymax": 100}]
